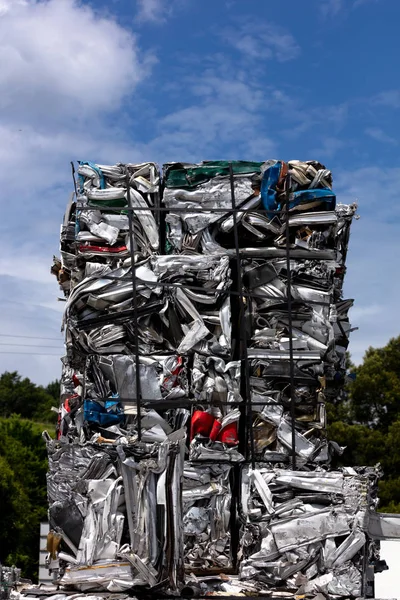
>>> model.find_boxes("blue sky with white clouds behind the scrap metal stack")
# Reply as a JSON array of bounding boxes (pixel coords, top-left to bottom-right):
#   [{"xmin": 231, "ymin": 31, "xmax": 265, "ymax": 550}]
[{"xmin": 0, "ymin": 0, "xmax": 400, "ymax": 383}]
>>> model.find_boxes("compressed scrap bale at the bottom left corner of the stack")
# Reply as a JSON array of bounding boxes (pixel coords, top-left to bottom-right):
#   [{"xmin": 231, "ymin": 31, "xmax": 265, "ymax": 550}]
[{"xmin": 47, "ymin": 431, "xmax": 184, "ymax": 591}]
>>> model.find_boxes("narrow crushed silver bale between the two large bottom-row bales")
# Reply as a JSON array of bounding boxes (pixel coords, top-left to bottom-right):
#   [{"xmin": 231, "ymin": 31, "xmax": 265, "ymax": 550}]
[{"xmin": 182, "ymin": 462, "xmax": 232, "ymax": 573}]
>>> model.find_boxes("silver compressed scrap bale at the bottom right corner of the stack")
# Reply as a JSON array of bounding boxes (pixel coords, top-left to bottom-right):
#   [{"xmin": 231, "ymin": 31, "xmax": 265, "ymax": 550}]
[{"xmin": 239, "ymin": 464, "xmax": 380, "ymax": 598}]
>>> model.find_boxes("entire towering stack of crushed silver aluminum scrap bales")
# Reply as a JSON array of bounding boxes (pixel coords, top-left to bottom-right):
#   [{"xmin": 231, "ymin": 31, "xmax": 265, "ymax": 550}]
[{"xmin": 44, "ymin": 160, "xmax": 388, "ymax": 600}]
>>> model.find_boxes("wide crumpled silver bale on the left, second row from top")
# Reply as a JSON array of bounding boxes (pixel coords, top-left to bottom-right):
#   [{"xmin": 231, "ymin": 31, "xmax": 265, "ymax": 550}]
[{"xmin": 64, "ymin": 256, "xmax": 231, "ymax": 358}]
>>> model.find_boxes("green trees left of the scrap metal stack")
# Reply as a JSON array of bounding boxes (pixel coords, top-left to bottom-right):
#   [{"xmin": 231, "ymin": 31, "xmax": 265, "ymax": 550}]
[{"xmin": 0, "ymin": 372, "xmax": 60, "ymax": 579}]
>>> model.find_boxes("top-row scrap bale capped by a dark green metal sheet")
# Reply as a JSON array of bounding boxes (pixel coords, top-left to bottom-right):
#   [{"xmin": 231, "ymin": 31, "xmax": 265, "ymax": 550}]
[{"xmin": 163, "ymin": 161, "xmax": 262, "ymax": 254}]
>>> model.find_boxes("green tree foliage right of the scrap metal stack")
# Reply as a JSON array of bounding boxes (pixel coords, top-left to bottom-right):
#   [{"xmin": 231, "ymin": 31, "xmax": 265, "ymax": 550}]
[{"xmin": 328, "ymin": 336, "xmax": 400, "ymax": 513}]
